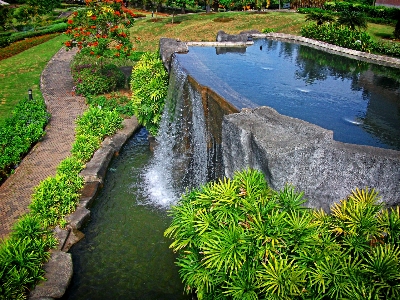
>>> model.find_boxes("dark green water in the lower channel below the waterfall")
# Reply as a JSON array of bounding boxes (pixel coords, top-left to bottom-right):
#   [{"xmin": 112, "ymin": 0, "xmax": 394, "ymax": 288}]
[{"xmin": 63, "ymin": 130, "xmax": 189, "ymax": 300}]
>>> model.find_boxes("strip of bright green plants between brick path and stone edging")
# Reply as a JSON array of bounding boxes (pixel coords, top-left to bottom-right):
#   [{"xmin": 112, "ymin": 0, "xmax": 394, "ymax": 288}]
[{"xmin": 0, "ymin": 92, "xmax": 133, "ymax": 299}]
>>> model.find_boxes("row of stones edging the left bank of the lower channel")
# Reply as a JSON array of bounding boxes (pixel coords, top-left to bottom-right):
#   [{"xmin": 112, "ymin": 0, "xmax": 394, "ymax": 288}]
[{"xmin": 29, "ymin": 117, "xmax": 140, "ymax": 300}]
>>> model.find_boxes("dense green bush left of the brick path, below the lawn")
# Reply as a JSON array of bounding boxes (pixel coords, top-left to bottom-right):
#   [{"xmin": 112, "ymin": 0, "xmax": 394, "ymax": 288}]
[{"xmin": 0, "ymin": 99, "xmax": 50, "ymax": 182}]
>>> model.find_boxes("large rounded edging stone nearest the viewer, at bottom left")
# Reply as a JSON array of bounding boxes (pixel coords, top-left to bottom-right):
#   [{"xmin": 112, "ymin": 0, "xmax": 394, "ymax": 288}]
[{"xmin": 29, "ymin": 251, "xmax": 73, "ymax": 300}]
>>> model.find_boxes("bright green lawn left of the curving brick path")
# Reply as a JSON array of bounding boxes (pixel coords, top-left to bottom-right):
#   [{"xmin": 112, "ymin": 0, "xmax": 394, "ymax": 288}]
[{"xmin": 0, "ymin": 35, "xmax": 66, "ymax": 126}]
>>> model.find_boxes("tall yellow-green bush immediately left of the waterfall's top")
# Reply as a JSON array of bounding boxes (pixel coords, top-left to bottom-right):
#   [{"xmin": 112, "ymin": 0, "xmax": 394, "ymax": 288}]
[{"xmin": 131, "ymin": 52, "xmax": 168, "ymax": 136}]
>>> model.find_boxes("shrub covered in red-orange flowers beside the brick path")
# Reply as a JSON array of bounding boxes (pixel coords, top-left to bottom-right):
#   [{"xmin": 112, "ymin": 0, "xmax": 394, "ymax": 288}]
[{"xmin": 65, "ymin": 0, "xmax": 135, "ymax": 58}]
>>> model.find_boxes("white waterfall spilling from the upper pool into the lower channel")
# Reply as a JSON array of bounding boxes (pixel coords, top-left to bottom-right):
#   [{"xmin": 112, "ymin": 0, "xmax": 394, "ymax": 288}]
[{"xmin": 144, "ymin": 59, "xmax": 213, "ymax": 207}]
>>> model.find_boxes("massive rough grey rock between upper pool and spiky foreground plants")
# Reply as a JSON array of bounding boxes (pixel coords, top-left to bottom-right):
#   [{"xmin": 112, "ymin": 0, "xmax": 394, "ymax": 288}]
[{"xmin": 222, "ymin": 107, "xmax": 400, "ymax": 210}]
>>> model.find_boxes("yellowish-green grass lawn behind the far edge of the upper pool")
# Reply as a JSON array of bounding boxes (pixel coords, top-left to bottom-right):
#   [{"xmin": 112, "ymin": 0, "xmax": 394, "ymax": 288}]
[{"xmin": 131, "ymin": 12, "xmax": 394, "ymax": 51}]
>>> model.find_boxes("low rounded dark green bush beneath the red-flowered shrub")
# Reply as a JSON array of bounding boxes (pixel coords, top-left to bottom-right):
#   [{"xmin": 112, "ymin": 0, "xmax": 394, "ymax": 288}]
[{"xmin": 72, "ymin": 64, "xmax": 125, "ymax": 96}]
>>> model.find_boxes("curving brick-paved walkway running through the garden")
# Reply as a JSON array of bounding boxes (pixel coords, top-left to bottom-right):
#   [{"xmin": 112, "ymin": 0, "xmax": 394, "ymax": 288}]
[{"xmin": 0, "ymin": 49, "xmax": 86, "ymax": 238}]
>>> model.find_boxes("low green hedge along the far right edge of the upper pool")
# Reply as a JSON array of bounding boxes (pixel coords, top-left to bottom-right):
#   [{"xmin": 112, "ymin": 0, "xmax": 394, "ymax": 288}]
[{"xmin": 301, "ymin": 24, "xmax": 373, "ymax": 52}]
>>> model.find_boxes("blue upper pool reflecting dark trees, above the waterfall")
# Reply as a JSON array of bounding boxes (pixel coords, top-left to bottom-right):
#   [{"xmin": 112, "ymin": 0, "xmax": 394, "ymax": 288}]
[{"xmin": 177, "ymin": 39, "xmax": 400, "ymax": 150}]
